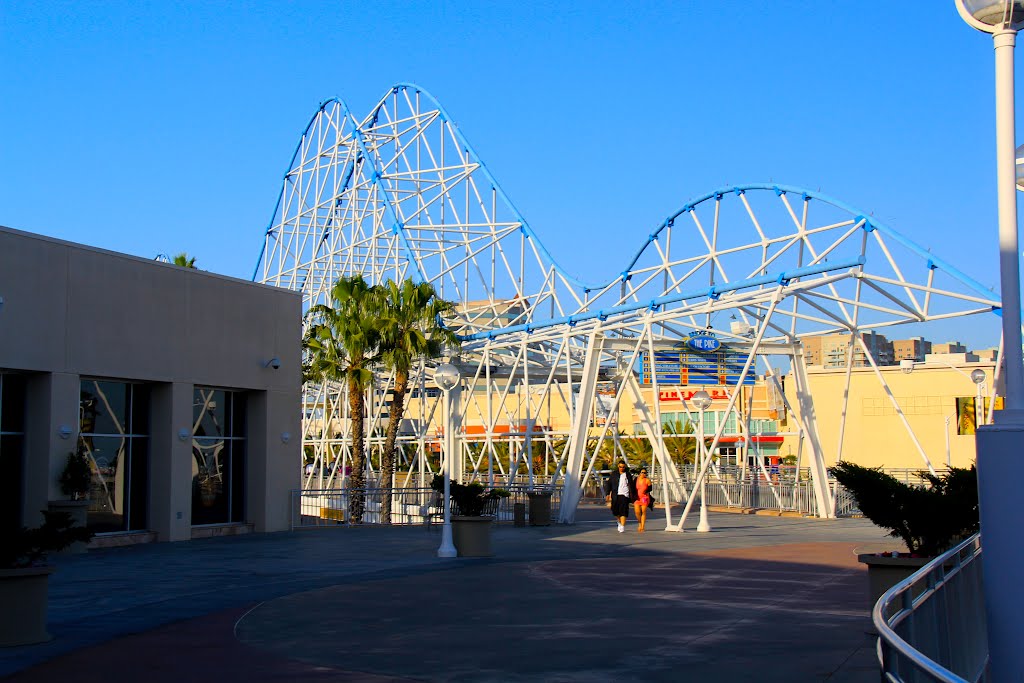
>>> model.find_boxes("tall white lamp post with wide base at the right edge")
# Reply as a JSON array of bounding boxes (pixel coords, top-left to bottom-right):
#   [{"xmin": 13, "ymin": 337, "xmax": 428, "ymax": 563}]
[{"xmin": 956, "ymin": 0, "xmax": 1024, "ymax": 681}]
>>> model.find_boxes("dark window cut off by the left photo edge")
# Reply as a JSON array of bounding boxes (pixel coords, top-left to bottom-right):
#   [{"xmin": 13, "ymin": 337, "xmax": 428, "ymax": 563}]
[{"xmin": 0, "ymin": 373, "xmax": 25, "ymax": 528}]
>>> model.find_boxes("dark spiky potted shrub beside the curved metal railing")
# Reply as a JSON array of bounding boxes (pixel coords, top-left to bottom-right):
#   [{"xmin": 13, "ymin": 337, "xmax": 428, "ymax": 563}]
[{"xmin": 828, "ymin": 462, "xmax": 979, "ymax": 605}]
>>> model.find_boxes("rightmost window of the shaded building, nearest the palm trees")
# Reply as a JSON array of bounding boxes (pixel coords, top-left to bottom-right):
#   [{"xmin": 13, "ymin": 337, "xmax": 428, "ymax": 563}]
[{"xmin": 191, "ymin": 387, "xmax": 246, "ymax": 524}]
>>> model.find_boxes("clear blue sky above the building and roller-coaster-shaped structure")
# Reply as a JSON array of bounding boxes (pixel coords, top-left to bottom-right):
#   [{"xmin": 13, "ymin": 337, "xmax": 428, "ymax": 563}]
[{"xmin": 0, "ymin": 0, "xmax": 1015, "ymax": 347}]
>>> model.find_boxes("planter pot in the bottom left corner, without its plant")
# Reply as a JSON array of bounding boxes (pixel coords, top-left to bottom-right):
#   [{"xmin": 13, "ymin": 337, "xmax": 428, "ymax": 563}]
[{"xmin": 0, "ymin": 566, "xmax": 53, "ymax": 647}]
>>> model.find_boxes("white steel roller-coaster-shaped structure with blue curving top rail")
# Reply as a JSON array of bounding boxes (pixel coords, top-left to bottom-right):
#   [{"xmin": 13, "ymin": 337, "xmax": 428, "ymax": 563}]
[{"xmin": 254, "ymin": 84, "xmax": 999, "ymax": 529}]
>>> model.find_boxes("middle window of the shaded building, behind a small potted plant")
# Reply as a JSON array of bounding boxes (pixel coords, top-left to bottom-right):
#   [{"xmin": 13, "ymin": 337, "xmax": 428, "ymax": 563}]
[{"xmin": 78, "ymin": 379, "xmax": 150, "ymax": 533}]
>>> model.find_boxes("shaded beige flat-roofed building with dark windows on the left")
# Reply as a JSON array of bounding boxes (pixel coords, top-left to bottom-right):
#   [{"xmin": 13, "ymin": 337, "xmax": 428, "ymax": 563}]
[{"xmin": 0, "ymin": 228, "xmax": 301, "ymax": 541}]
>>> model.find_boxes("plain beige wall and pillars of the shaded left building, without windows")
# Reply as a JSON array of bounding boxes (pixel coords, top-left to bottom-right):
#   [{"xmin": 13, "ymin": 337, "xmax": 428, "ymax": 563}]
[{"xmin": 0, "ymin": 227, "xmax": 301, "ymax": 540}]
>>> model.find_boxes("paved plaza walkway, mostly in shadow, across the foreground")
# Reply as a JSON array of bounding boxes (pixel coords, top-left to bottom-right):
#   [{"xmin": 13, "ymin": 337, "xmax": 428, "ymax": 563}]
[{"xmin": 0, "ymin": 509, "xmax": 892, "ymax": 683}]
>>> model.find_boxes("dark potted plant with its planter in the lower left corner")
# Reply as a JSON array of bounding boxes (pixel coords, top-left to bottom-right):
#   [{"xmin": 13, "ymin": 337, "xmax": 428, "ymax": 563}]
[{"xmin": 0, "ymin": 510, "xmax": 92, "ymax": 647}]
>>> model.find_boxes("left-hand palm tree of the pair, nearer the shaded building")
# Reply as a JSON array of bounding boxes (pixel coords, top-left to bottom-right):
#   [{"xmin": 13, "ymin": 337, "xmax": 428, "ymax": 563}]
[{"xmin": 303, "ymin": 274, "xmax": 381, "ymax": 524}]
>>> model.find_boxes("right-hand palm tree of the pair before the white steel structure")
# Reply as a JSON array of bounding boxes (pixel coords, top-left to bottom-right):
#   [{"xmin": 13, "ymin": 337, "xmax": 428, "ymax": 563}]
[{"xmin": 378, "ymin": 279, "xmax": 459, "ymax": 524}]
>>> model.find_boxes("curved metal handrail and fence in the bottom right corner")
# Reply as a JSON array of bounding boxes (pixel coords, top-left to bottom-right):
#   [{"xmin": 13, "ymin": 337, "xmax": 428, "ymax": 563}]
[{"xmin": 871, "ymin": 533, "xmax": 988, "ymax": 683}]
